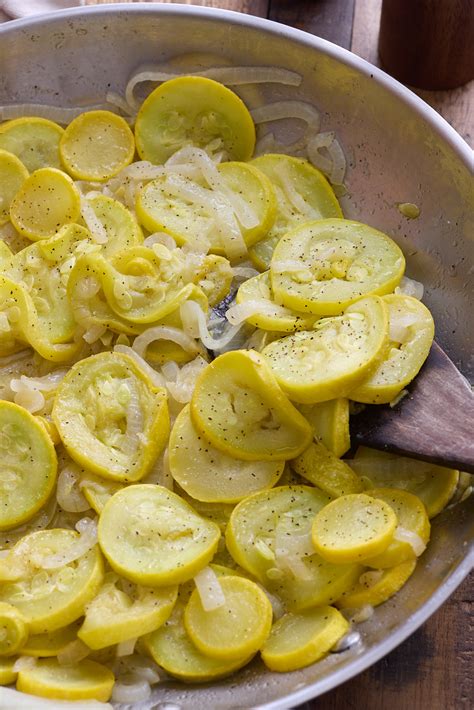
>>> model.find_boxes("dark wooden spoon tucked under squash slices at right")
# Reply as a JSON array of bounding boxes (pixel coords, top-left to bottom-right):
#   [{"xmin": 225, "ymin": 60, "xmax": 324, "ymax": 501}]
[{"xmin": 351, "ymin": 343, "xmax": 474, "ymax": 473}]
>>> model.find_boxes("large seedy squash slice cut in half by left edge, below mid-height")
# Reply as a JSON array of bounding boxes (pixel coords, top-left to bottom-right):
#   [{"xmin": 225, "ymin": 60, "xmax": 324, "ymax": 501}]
[{"xmin": 0, "ymin": 400, "xmax": 58, "ymax": 530}]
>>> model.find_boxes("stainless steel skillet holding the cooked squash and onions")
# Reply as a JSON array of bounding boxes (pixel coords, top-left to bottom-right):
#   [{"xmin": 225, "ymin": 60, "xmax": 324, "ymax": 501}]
[{"xmin": 0, "ymin": 4, "xmax": 474, "ymax": 710}]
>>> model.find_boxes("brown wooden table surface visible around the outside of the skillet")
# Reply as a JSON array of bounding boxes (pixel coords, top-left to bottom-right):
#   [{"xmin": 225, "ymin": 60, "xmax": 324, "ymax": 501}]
[{"xmin": 0, "ymin": 0, "xmax": 474, "ymax": 710}]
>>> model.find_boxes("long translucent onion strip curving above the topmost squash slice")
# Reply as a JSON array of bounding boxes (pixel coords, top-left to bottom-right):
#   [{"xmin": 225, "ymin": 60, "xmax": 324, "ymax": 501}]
[{"xmin": 125, "ymin": 65, "xmax": 302, "ymax": 108}]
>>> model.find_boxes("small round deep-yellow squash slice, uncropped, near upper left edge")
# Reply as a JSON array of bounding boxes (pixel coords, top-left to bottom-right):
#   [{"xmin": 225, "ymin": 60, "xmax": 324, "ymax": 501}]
[{"xmin": 10, "ymin": 168, "xmax": 80, "ymax": 241}]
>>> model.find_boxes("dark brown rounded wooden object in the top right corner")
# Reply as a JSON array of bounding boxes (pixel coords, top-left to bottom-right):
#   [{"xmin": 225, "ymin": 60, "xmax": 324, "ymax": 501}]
[{"xmin": 379, "ymin": 0, "xmax": 474, "ymax": 89}]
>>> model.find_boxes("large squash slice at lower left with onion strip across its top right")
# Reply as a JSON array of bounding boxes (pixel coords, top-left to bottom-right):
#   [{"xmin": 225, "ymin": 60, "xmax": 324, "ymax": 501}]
[{"xmin": 0, "ymin": 529, "xmax": 103, "ymax": 634}]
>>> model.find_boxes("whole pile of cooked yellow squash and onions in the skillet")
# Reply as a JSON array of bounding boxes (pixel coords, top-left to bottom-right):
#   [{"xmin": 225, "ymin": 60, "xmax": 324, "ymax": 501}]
[{"xmin": 0, "ymin": 62, "xmax": 468, "ymax": 702}]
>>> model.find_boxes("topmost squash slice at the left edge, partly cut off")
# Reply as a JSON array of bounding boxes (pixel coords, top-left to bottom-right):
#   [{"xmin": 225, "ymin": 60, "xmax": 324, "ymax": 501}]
[{"xmin": 0, "ymin": 117, "xmax": 64, "ymax": 172}]
